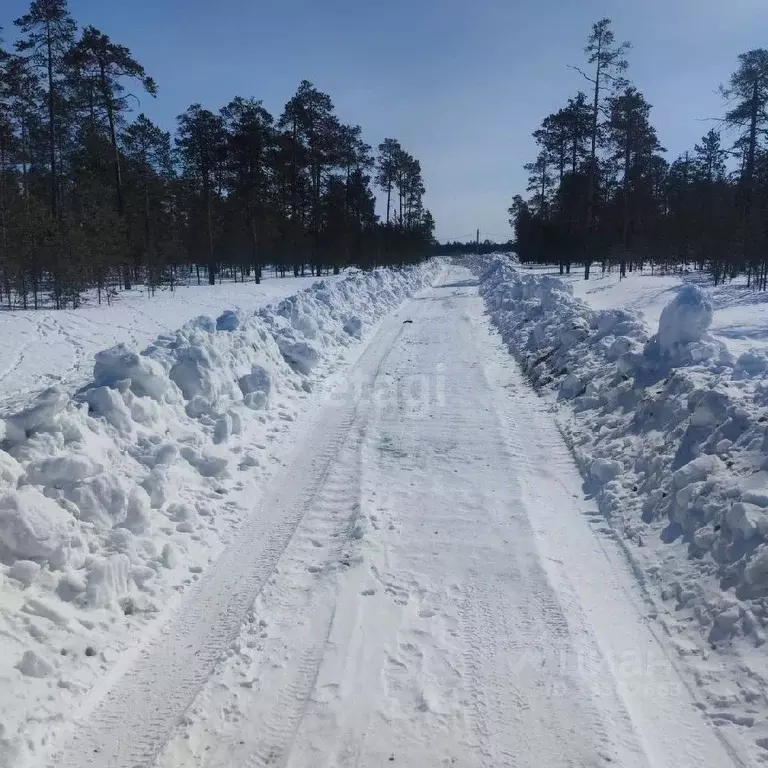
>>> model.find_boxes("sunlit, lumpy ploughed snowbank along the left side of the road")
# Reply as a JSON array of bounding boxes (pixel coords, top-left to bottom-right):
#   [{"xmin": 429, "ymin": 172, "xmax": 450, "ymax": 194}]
[{"xmin": 0, "ymin": 263, "xmax": 437, "ymax": 765}]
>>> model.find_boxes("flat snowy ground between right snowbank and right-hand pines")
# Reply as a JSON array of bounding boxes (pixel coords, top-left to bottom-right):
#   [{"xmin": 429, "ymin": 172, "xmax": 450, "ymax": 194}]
[{"xmin": 523, "ymin": 266, "xmax": 768, "ymax": 356}]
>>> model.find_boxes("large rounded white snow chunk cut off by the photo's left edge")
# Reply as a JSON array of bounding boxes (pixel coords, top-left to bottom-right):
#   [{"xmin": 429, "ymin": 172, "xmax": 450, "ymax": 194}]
[{"xmin": 0, "ymin": 488, "xmax": 71, "ymax": 560}]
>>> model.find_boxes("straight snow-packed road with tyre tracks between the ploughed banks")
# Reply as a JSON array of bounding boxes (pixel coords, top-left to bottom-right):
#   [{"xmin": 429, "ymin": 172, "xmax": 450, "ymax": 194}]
[{"xmin": 42, "ymin": 268, "xmax": 747, "ymax": 768}]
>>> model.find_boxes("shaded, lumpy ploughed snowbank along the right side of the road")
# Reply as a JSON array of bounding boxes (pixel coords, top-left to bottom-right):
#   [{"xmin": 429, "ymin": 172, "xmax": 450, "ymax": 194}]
[{"xmin": 478, "ymin": 257, "xmax": 768, "ymax": 645}]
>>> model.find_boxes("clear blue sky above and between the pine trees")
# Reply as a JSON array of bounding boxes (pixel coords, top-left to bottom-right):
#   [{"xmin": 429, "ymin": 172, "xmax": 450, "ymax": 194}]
[{"xmin": 0, "ymin": 0, "xmax": 768, "ymax": 239}]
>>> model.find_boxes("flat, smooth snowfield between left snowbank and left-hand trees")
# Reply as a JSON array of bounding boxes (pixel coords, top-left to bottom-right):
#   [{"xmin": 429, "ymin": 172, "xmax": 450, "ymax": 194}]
[{"xmin": 0, "ymin": 277, "xmax": 337, "ymax": 415}]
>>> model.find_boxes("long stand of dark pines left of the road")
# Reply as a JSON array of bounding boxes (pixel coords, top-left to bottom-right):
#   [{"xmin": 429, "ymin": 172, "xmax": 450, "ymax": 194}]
[{"xmin": 0, "ymin": 0, "xmax": 434, "ymax": 308}]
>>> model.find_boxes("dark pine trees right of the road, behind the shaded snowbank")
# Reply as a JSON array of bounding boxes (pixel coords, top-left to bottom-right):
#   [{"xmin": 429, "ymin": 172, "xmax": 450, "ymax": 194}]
[{"xmin": 509, "ymin": 19, "xmax": 768, "ymax": 290}]
